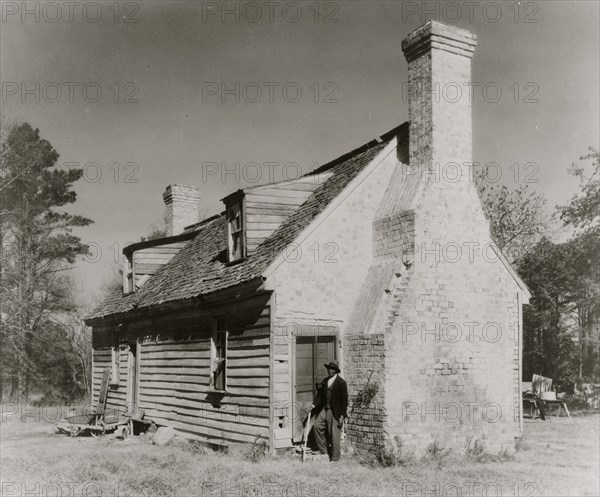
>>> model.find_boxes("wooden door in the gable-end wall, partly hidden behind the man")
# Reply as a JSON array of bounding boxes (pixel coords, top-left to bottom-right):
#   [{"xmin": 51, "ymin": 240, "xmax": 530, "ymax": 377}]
[{"xmin": 292, "ymin": 336, "xmax": 337, "ymax": 442}]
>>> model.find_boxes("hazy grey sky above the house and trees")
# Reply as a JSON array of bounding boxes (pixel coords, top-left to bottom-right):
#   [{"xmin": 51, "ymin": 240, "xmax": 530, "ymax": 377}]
[{"xmin": 0, "ymin": 0, "xmax": 600, "ymax": 296}]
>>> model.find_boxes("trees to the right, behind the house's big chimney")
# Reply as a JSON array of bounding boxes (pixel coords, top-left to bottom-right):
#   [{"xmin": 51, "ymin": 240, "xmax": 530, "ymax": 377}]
[{"xmin": 478, "ymin": 147, "xmax": 600, "ymax": 389}]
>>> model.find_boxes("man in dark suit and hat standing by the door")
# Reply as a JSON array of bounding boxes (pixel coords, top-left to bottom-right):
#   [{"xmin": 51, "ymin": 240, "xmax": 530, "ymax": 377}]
[{"xmin": 310, "ymin": 360, "xmax": 348, "ymax": 461}]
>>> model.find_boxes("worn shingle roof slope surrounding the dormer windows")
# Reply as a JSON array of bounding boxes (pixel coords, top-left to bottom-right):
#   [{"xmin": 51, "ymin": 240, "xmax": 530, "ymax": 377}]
[{"xmin": 88, "ymin": 125, "xmax": 407, "ymax": 320}]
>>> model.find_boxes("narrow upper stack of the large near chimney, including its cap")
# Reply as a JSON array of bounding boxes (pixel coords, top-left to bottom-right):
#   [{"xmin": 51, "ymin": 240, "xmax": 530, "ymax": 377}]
[{"xmin": 402, "ymin": 21, "xmax": 477, "ymax": 180}]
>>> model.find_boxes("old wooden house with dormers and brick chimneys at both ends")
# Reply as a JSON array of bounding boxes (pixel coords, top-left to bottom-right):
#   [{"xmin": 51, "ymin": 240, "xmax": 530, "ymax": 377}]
[{"xmin": 87, "ymin": 22, "xmax": 530, "ymax": 456}]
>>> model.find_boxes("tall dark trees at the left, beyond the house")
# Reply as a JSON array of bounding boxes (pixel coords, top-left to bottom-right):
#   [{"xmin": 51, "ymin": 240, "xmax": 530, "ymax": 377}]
[{"xmin": 0, "ymin": 123, "xmax": 92, "ymax": 402}]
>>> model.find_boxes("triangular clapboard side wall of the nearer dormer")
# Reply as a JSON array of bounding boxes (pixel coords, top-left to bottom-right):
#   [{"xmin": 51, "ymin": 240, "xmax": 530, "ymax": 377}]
[{"xmin": 244, "ymin": 175, "xmax": 329, "ymax": 253}]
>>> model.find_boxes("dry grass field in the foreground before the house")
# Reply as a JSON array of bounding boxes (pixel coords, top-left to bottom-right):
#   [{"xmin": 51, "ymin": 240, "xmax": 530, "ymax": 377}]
[{"xmin": 0, "ymin": 406, "xmax": 600, "ymax": 497}]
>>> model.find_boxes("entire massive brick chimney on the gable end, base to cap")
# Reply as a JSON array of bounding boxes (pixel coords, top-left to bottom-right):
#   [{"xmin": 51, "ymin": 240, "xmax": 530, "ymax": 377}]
[{"xmin": 344, "ymin": 22, "xmax": 528, "ymax": 453}]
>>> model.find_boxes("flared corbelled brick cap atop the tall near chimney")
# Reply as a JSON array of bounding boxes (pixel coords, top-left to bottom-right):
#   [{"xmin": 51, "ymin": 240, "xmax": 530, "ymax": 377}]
[{"xmin": 402, "ymin": 21, "xmax": 477, "ymax": 62}]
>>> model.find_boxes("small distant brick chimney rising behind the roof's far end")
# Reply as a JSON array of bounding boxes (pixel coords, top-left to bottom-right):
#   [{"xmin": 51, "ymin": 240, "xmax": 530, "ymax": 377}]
[{"xmin": 163, "ymin": 185, "xmax": 202, "ymax": 236}]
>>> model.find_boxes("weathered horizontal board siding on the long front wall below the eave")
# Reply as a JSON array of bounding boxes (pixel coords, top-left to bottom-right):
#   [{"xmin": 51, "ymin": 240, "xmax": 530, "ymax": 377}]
[{"xmin": 94, "ymin": 294, "xmax": 271, "ymax": 445}]
